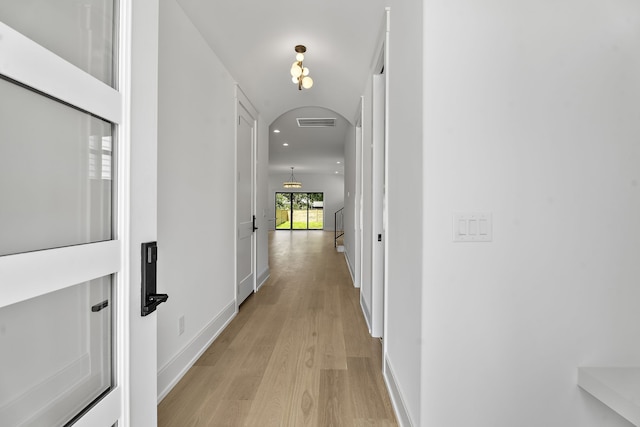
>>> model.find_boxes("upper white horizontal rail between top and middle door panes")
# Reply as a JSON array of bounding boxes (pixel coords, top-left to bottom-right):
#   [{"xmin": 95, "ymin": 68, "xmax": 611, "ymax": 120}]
[{"xmin": 0, "ymin": 22, "xmax": 122, "ymax": 123}]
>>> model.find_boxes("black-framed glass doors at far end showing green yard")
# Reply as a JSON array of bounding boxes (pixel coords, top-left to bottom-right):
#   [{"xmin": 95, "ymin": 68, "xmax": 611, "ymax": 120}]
[{"xmin": 275, "ymin": 192, "xmax": 324, "ymax": 230}]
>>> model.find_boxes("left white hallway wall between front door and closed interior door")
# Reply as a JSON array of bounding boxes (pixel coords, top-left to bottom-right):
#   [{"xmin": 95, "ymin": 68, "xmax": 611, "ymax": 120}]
[{"xmin": 158, "ymin": 0, "xmax": 235, "ymax": 397}]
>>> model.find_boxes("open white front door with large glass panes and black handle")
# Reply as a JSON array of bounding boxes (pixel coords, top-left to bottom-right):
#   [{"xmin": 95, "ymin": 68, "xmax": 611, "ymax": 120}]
[{"xmin": 0, "ymin": 0, "xmax": 157, "ymax": 427}]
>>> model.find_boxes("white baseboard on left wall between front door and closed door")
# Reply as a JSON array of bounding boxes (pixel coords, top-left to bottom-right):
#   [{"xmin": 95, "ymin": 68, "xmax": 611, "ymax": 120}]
[{"xmin": 158, "ymin": 300, "xmax": 237, "ymax": 403}]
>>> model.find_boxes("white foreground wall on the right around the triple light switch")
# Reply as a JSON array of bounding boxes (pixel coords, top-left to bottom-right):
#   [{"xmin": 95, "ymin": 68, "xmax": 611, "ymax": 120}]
[{"xmin": 420, "ymin": 0, "xmax": 640, "ymax": 427}]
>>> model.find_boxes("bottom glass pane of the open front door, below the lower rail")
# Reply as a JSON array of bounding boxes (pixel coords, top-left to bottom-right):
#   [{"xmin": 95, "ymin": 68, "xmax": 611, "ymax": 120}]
[{"xmin": 0, "ymin": 275, "xmax": 114, "ymax": 426}]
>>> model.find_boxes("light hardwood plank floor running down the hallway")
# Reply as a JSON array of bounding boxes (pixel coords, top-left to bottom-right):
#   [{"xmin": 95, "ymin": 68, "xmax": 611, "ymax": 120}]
[{"xmin": 158, "ymin": 231, "xmax": 397, "ymax": 427}]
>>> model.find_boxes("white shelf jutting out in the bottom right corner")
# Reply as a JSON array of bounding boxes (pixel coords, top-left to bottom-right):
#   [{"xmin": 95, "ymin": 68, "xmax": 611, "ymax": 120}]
[{"xmin": 578, "ymin": 367, "xmax": 640, "ymax": 426}]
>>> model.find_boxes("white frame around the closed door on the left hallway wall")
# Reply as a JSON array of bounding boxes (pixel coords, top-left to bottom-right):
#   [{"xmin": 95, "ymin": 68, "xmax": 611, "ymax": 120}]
[{"xmin": 234, "ymin": 84, "xmax": 259, "ymax": 312}]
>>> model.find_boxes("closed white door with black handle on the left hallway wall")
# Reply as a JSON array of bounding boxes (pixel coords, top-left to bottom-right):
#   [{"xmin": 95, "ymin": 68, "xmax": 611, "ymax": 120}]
[{"xmin": 236, "ymin": 92, "xmax": 256, "ymax": 305}]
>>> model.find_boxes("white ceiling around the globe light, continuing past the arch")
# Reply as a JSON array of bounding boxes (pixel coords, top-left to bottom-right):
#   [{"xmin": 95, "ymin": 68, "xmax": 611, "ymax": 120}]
[{"xmin": 172, "ymin": 0, "xmax": 387, "ymax": 175}]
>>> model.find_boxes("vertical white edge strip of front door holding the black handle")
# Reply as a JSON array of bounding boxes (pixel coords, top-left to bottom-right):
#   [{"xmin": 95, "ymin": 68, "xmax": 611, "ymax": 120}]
[{"xmin": 122, "ymin": 0, "xmax": 160, "ymax": 427}]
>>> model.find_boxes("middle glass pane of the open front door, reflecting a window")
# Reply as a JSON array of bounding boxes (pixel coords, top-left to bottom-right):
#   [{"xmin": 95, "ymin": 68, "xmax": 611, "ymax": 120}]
[{"xmin": 0, "ymin": 79, "xmax": 114, "ymax": 255}]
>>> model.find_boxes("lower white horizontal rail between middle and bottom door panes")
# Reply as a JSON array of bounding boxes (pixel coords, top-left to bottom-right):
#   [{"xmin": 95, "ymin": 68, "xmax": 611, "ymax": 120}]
[{"xmin": 0, "ymin": 240, "xmax": 121, "ymax": 307}]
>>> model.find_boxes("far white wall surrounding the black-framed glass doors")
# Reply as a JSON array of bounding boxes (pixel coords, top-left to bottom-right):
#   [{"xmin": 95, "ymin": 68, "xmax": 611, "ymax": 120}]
[{"xmin": 267, "ymin": 172, "xmax": 344, "ymax": 231}]
